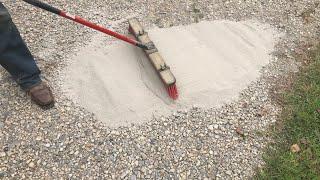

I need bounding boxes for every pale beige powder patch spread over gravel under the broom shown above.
[64,21,279,127]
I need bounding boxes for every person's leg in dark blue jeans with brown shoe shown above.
[0,3,54,108]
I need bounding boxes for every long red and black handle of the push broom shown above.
[23,0,147,48]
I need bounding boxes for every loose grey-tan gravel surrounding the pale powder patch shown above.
[0,0,320,179]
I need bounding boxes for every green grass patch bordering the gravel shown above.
[256,47,320,180]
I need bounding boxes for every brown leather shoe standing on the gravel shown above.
[28,82,54,109]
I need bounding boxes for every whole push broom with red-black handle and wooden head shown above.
[23,0,178,100]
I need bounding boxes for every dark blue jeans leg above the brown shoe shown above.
[0,3,41,90]
